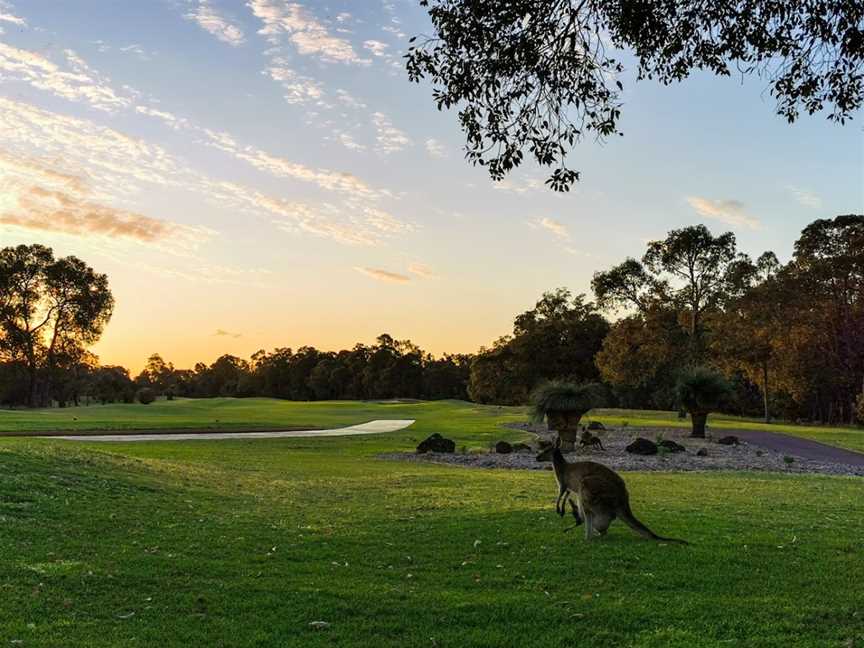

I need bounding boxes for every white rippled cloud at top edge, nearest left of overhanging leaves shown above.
[247,0,369,65]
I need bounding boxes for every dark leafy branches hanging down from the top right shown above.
[407,0,864,191]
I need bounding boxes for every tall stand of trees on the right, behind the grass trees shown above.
[469,215,864,423]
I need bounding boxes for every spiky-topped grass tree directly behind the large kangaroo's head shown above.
[531,380,604,450]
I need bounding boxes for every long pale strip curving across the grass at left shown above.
[42,419,414,443]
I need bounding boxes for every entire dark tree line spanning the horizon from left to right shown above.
[0,215,864,423]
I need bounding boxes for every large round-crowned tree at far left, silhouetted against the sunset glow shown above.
[0,245,114,407]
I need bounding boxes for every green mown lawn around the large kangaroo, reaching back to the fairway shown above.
[0,401,864,648]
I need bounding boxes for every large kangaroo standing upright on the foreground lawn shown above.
[552,446,689,544]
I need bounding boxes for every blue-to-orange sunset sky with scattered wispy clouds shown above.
[0,0,864,370]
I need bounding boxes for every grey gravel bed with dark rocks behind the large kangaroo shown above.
[381,424,864,476]
